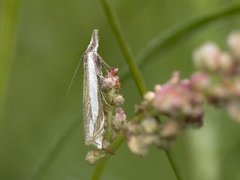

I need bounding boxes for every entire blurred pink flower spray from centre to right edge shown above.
[126,32,240,155]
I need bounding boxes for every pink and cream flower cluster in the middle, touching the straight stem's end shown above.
[127,72,204,155]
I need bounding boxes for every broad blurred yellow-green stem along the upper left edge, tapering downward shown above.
[0,0,19,115]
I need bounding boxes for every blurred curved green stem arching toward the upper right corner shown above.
[121,2,240,80]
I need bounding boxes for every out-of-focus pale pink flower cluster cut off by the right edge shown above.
[194,32,240,122]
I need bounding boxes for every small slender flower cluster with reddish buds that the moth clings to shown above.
[86,68,126,164]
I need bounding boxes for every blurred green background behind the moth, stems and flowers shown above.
[0,0,240,180]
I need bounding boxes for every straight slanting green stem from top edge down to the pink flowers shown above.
[100,0,146,95]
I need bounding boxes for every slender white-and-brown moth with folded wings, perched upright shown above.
[83,29,105,149]
